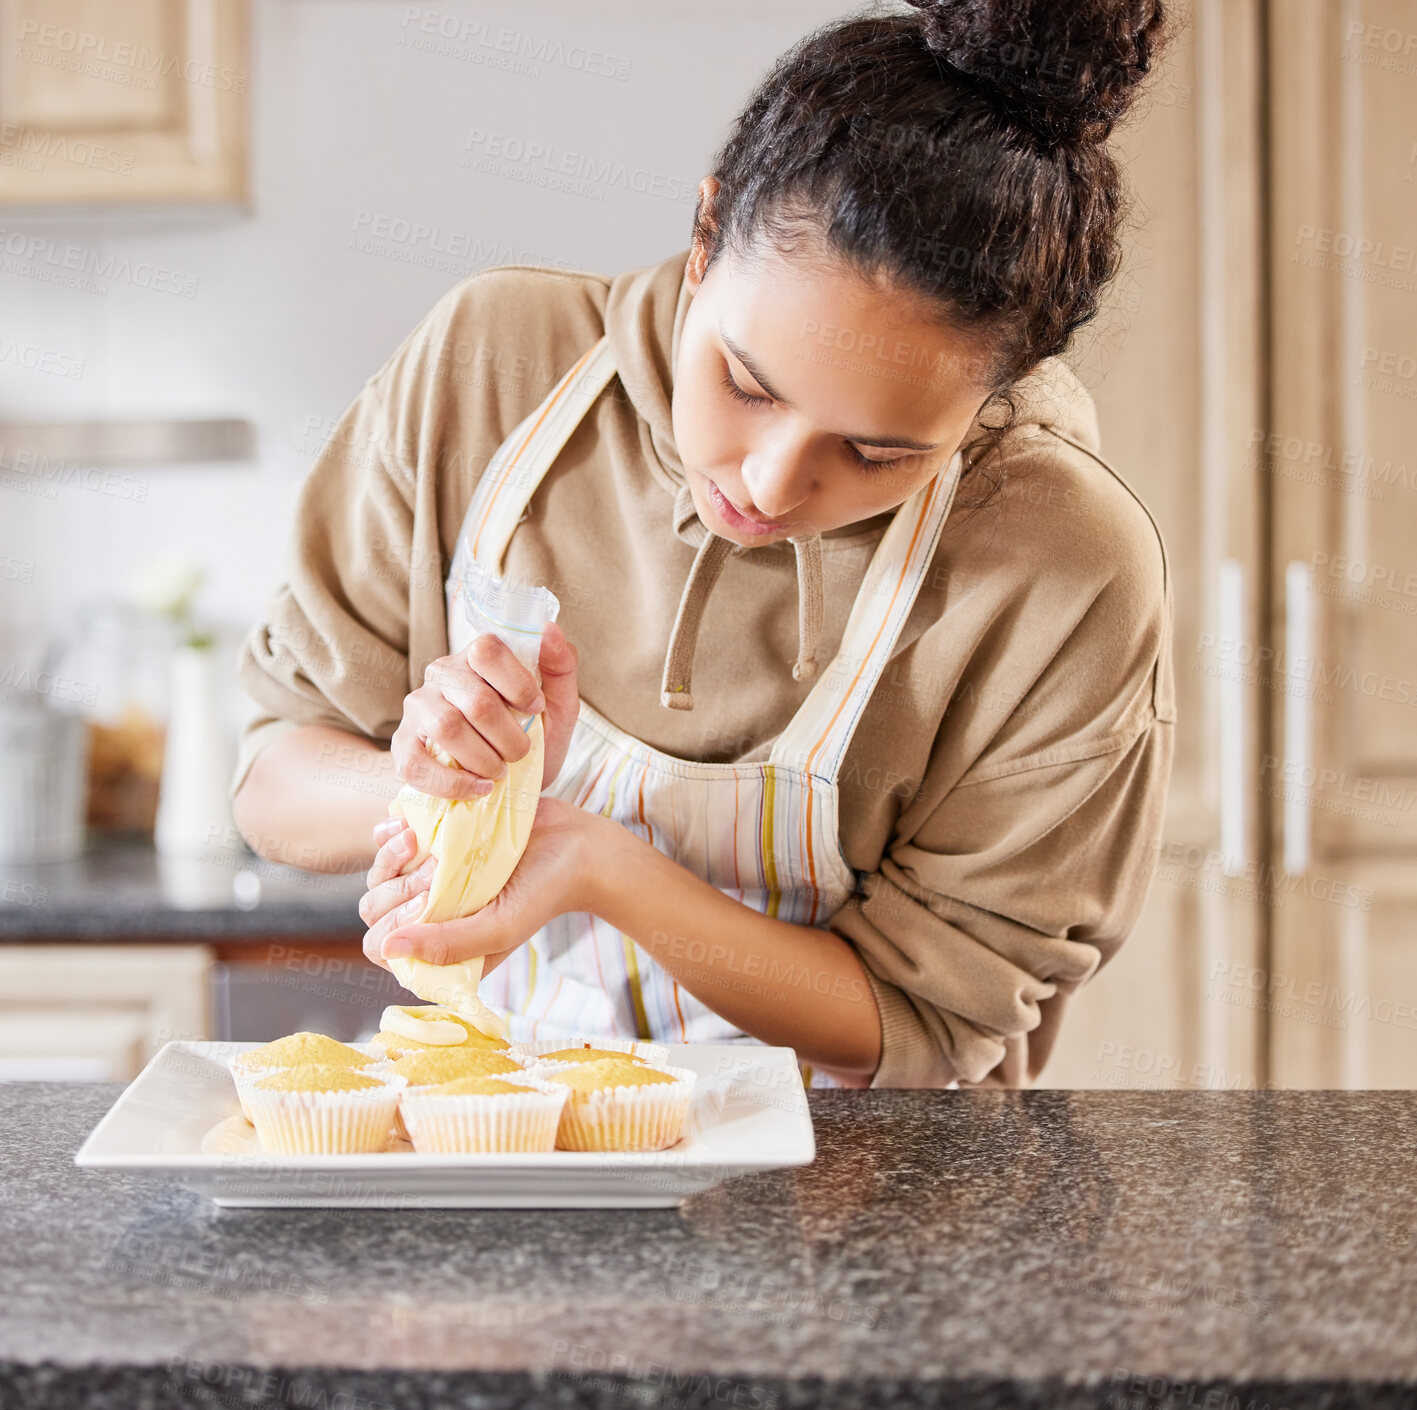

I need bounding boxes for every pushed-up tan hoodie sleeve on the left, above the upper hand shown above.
[230,269,521,796]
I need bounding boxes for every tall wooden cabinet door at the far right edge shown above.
[1260,0,1417,1087]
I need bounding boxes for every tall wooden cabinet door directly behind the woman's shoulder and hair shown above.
[1040,0,1265,1088]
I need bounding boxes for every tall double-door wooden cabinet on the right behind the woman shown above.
[1043,0,1417,1087]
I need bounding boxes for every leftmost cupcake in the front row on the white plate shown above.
[245,1064,407,1155]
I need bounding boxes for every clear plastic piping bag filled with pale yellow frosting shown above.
[385,538,561,1046]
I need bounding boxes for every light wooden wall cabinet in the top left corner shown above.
[0,0,249,205]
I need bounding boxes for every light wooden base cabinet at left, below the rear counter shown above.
[0,944,213,1081]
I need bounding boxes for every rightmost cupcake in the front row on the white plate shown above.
[533,1054,694,1151]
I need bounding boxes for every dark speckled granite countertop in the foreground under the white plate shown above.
[0,1084,1417,1410]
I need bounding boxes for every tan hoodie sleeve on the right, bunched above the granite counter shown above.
[830,478,1175,1087]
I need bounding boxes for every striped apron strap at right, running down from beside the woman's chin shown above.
[769,451,964,779]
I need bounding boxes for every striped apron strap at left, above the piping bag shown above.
[459,337,615,577]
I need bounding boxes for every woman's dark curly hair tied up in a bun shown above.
[694,0,1166,478]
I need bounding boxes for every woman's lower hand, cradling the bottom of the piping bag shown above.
[360,795,604,974]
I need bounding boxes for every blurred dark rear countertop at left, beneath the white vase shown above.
[0,835,366,942]
